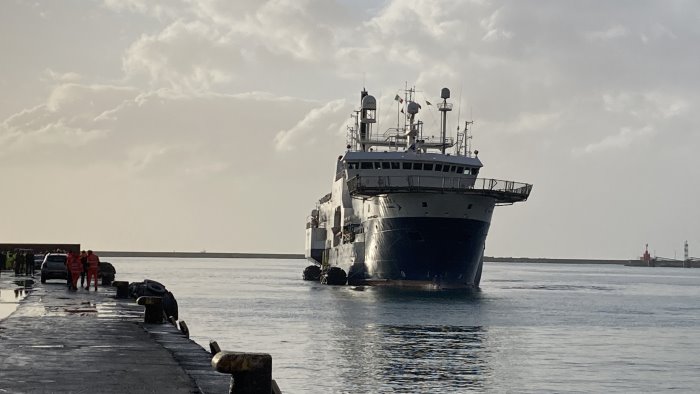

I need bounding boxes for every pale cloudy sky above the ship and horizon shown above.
[0,0,700,259]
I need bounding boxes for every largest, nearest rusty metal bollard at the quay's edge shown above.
[211,351,273,394]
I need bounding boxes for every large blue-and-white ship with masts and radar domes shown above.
[304,87,532,289]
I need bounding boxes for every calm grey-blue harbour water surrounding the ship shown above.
[109,258,700,393]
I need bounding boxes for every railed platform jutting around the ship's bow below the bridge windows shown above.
[348,175,532,204]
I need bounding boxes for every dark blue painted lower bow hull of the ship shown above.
[364,217,489,287]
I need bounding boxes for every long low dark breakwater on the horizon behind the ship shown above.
[96,250,630,265]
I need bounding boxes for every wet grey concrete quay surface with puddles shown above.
[0,271,230,393]
